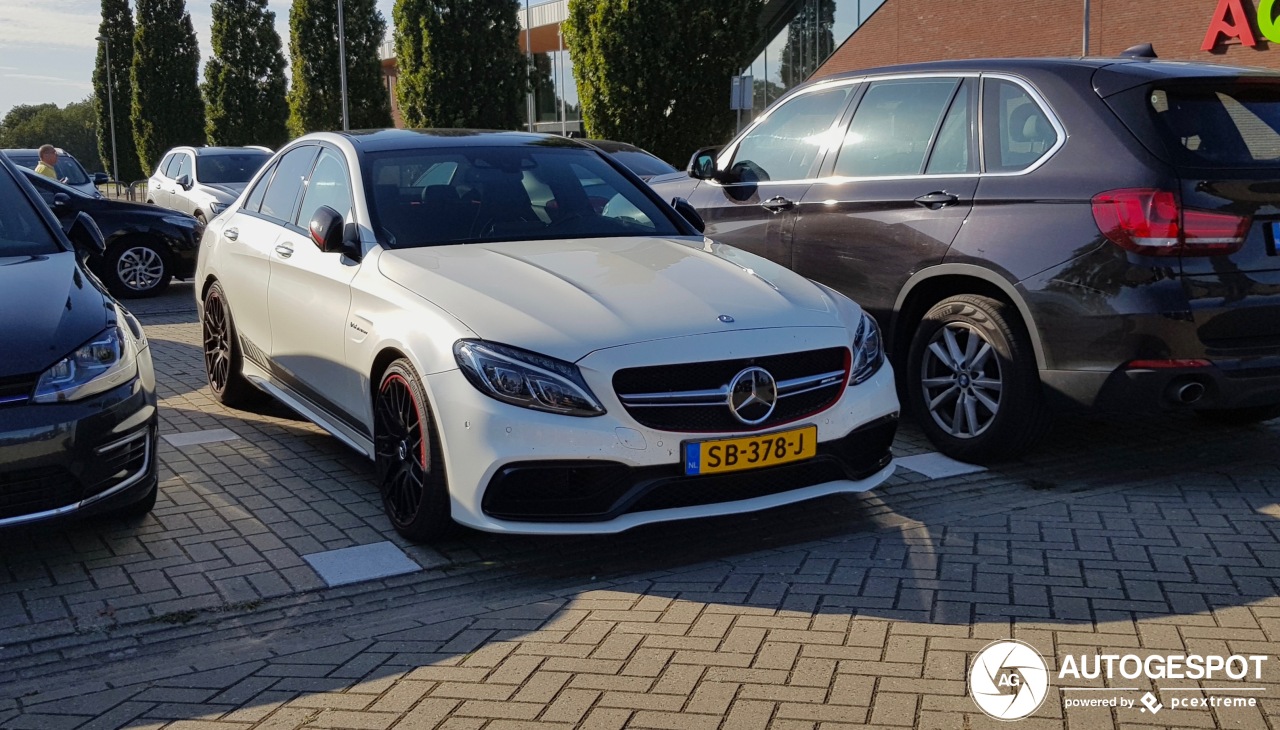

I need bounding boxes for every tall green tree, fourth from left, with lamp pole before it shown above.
[289,0,392,136]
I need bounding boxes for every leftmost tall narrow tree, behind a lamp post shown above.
[93,0,142,183]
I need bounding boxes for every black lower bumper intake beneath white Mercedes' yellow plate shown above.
[481,415,897,523]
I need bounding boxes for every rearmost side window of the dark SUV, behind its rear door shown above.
[982,78,1057,172]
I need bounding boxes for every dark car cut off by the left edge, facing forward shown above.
[0,151,157,528]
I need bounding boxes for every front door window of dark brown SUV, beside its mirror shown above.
[731,83,854,182]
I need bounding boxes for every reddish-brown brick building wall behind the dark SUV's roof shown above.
[814,0,1280,78]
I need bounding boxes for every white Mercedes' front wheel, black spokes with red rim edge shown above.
[374,359,453,542]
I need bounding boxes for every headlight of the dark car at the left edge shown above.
[32,310,141,403]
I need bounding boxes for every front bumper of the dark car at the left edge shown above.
[0,350,159,529]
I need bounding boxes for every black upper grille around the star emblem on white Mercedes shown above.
[613,347,849,433]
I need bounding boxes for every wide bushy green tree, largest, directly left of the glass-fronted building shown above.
[562,0,760,165]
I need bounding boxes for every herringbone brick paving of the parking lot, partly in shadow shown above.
[0,284,1280,730]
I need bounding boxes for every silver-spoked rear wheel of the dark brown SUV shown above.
[906,295,1050,462]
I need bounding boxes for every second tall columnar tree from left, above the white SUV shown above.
[131,0,205,175]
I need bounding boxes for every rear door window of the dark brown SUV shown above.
[835,78,960,177]
